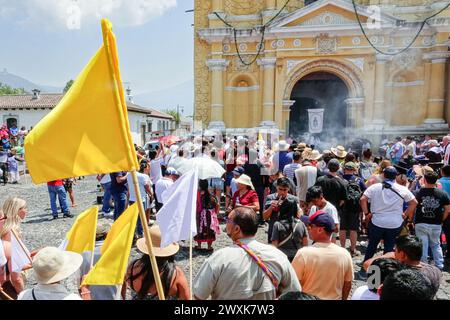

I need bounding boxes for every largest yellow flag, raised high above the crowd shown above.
[25,19,139,184]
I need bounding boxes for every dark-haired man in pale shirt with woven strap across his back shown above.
[193,207,301,300]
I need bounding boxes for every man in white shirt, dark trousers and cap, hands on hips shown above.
[360,167,417,261]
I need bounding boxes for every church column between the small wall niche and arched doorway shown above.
[258,57,277,127]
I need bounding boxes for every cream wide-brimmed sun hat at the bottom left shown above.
[32,247,83,284]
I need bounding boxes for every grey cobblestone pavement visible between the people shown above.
[0,176,450,300]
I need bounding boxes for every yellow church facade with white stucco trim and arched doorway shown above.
[195,0,450,140]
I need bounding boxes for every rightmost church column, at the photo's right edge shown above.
[424,51,449,128]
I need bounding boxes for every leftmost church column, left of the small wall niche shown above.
[206,59,230,129]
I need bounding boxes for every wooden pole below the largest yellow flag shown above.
[131,170,165,300]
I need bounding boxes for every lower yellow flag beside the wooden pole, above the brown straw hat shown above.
[82,203,138,286]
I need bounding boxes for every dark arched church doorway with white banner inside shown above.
[289,72,351,144]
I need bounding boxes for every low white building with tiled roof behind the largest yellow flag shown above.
[0,90,174,146]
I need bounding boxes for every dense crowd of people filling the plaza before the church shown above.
[0,131,450,300]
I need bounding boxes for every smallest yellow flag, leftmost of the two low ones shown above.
[66,206,98,253]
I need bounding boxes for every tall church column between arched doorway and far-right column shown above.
[372,54,392,127]
